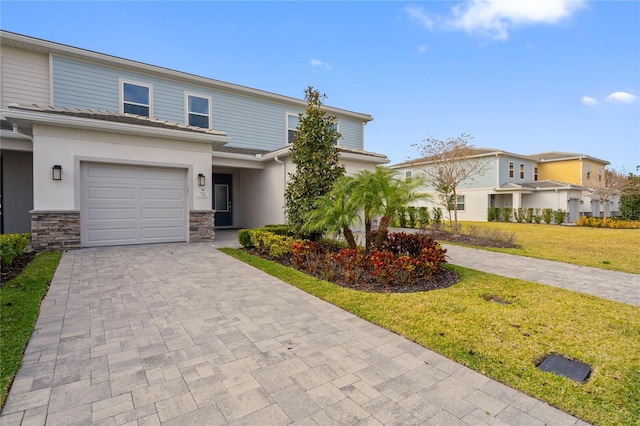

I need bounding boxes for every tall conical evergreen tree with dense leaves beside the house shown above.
[285,86,345,239]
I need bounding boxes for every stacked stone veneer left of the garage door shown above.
[29,210,80,251]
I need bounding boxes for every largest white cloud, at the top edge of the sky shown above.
[405,0,586,40]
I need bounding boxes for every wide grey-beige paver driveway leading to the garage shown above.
[0,244,584,425]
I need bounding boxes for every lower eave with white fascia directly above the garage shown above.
[0,109,229,144]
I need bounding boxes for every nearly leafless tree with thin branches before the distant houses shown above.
[417,133,490,232]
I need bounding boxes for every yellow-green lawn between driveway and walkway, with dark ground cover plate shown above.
[222,249,640,425]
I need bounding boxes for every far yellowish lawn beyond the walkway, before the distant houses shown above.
[450,222,640,274]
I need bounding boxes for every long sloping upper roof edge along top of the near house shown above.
[0,30,373,122]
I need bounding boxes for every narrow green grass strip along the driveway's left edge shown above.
[0,252,62,407]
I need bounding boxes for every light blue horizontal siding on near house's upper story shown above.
[53,56,364,151]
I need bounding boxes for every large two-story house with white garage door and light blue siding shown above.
[0,31,388,250]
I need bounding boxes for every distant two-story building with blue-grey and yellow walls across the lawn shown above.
[390,148,609,222]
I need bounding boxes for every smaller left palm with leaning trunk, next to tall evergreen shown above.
[302,176,361,249]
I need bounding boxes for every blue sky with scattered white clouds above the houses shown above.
[0,0,640,171]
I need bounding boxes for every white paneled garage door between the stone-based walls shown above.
[80,163,187,247]
